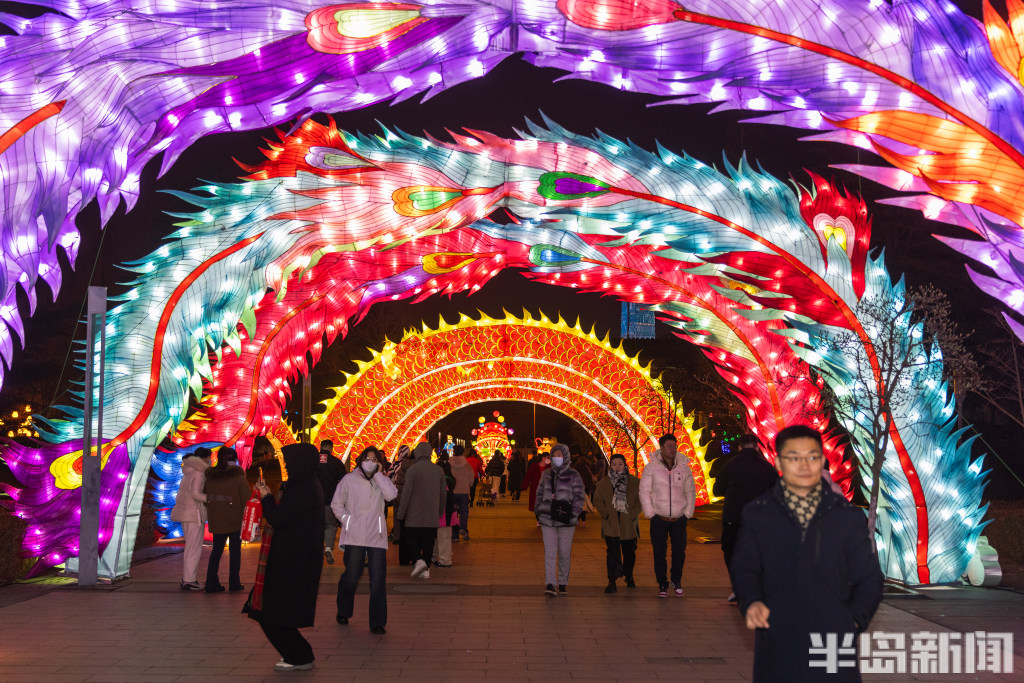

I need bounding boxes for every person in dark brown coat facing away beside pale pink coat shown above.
[205,445,249,593]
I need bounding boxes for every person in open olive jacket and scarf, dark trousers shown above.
[594,453,641,593]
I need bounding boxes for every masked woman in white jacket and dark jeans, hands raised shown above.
[331,446,398,634]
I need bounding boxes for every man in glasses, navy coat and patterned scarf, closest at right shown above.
[730,425,884,683]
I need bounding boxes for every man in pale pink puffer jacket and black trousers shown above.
[640,434,697,598]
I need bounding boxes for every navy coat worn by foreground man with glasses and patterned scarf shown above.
[730,483,884,683]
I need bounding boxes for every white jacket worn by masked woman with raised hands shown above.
[331,468,398,550]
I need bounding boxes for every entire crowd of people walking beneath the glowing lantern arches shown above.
[171,426,883,680]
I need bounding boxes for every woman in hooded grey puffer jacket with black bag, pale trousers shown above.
[534,443,586,595]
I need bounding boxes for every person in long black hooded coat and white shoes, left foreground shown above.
[244,443,324,671]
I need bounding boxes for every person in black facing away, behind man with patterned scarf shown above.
[713,434,778,602]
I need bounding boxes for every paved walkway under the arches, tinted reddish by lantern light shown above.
[0,501,1024,683]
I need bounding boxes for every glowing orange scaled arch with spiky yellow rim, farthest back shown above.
[313,313,711,503]
